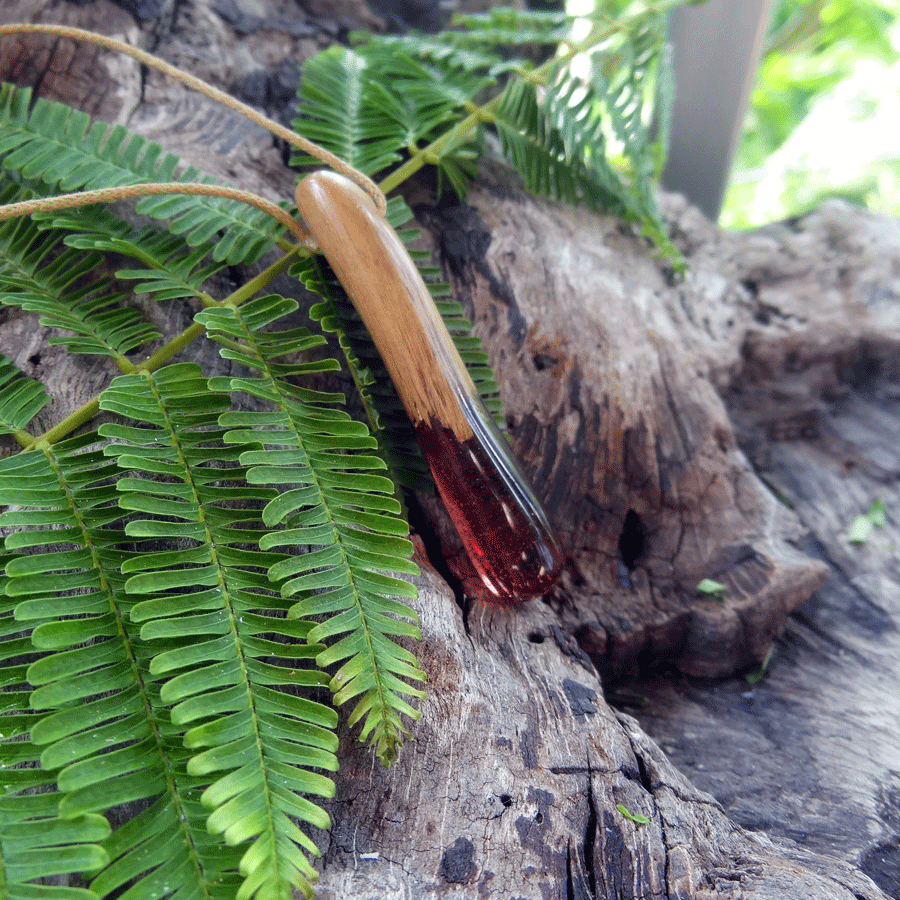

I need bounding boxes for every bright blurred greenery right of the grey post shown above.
[722,0,900,227]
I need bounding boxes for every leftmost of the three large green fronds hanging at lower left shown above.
[0,434,238,900]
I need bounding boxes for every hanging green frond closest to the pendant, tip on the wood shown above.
[196,296,424,760]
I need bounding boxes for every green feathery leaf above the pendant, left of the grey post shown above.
[294,10,676,258]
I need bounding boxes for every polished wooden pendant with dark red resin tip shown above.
[296,171,562,604]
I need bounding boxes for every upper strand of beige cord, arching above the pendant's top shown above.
[0,23,387,217]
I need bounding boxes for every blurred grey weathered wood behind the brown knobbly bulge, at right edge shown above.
[627,195,900,897]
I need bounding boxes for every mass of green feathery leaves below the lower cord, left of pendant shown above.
[0,81,432,898]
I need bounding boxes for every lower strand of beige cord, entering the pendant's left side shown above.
[0,181,318,252]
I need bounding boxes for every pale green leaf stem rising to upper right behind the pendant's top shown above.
[378,0,695,194]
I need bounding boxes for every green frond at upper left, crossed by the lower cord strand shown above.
[0,84,283,265]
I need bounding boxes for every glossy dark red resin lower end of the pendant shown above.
[416,403,562,603]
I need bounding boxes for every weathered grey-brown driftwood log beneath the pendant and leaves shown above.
[0,0,900,900]
